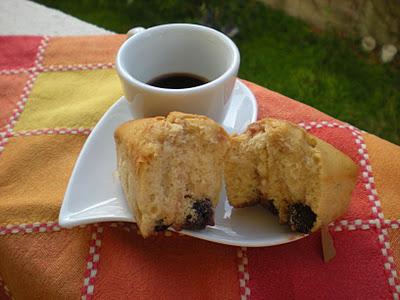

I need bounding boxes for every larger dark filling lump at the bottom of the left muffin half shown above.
[183,198,214,230]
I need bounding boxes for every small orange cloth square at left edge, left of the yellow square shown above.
[0,74,29,131]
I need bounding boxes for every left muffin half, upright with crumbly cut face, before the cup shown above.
[114,112,229,237]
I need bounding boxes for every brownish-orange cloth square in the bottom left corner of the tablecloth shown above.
[0,228,90,299]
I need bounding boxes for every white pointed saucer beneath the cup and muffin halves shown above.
[59,81,304,247]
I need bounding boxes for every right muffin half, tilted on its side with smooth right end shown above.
[225,118,358,233]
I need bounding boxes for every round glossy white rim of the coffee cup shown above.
[116,23,240,94]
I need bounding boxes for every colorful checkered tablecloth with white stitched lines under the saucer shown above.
[0,35,400,299]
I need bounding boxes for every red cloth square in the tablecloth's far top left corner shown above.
[0,36,42,69]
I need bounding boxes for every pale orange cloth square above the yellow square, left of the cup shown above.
[43,34,126,66]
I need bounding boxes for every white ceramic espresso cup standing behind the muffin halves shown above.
[116,24,240,122]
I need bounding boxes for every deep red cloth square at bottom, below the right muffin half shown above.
[247,230,392,299]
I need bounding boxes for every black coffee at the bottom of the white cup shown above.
[147,73,209,89]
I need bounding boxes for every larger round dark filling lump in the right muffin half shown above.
[288,203,317,233]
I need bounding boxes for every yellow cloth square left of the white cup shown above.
[15,69,122,131]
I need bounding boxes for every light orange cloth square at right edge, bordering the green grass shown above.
[363,133,400,219]
